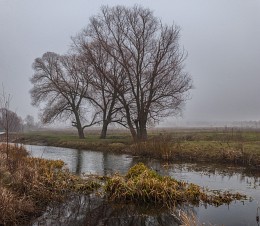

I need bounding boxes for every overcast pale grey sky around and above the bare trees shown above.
[0,0,260,125]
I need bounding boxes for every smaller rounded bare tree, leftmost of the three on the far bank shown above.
[30,52,99,139]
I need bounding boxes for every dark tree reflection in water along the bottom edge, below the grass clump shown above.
[32,195,179,226]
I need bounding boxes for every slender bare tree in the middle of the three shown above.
[74,40,122,139]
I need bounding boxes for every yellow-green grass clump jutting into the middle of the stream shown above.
[105,163,244,207]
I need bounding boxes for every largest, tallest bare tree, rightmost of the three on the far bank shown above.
[78,6,192,140]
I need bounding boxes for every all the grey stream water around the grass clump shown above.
[26,145,260,226]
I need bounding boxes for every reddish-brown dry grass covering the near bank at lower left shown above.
[0,145,100,225]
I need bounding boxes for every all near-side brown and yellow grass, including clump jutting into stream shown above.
[0,143,252,225]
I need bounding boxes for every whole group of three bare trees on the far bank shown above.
[30,6,192,140]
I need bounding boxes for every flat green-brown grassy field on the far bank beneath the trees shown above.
[19,128,260,168]
